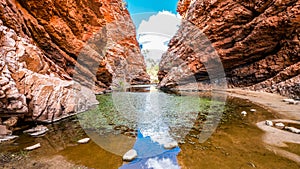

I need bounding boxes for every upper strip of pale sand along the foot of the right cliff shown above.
[223,89,300,120]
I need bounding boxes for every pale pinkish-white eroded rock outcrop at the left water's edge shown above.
[0,23,98,121]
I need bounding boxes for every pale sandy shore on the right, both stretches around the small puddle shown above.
[222,89,300,165]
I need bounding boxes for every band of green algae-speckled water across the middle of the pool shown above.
[77,92,224,137]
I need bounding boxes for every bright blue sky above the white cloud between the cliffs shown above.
[125,0,178,27]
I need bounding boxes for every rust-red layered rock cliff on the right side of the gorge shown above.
[158,0,300,98]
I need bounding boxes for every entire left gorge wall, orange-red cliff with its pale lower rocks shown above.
[0,0,149,121]
